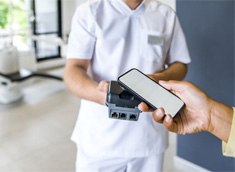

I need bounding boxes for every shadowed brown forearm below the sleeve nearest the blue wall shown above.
[152,62,187,81]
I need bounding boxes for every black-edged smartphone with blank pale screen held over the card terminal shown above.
[118,68,184,117]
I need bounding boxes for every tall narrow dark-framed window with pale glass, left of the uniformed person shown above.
[31,0,62,61]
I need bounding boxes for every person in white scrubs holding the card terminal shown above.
[64,0,190,172]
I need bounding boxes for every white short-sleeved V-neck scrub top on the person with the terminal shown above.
[67,0,190,157]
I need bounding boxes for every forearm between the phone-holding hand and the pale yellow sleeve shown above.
[208,100,233,142]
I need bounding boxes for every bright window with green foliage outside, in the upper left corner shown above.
[0,0,28,49]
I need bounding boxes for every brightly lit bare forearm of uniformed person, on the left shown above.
[64,62,105,104]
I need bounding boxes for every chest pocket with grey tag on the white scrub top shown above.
[144,31,165,63]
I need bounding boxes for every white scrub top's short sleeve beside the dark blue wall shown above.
[167,15,191,64]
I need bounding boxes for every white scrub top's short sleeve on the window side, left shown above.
[67,4,96,60]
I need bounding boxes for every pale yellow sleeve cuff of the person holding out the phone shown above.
[222,108,235,157]
